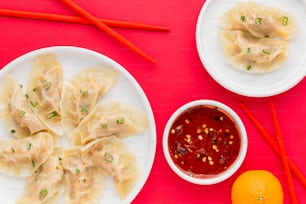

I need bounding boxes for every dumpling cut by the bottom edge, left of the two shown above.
[16,149,64,204]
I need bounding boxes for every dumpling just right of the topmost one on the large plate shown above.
[61,67,118,137]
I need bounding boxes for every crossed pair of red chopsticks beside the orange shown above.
[240,103,306,204]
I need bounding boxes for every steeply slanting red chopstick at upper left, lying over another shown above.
[60,0,156,63]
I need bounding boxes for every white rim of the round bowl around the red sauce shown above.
[162,99,248,185]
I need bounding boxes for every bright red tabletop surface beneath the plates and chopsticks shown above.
[0,0,306,204]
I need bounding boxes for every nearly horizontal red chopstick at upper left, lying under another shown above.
[0,8,170,31]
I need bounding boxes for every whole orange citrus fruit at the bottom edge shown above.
[231,170,284,204]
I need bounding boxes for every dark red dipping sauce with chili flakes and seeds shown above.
[168,105,241,176]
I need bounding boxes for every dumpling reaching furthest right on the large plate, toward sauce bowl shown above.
[72,102,148,145]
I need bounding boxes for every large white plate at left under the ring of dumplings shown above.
[0,47,156,204]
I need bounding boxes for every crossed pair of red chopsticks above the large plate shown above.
[0,0,169,63]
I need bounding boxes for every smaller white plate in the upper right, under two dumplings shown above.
[196,0,306,97]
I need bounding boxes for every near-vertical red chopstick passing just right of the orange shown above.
[270,103,298,204]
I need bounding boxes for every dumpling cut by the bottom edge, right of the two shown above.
[63,147,104,204]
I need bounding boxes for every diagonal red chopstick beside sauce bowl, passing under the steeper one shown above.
[240,103,306,188]
